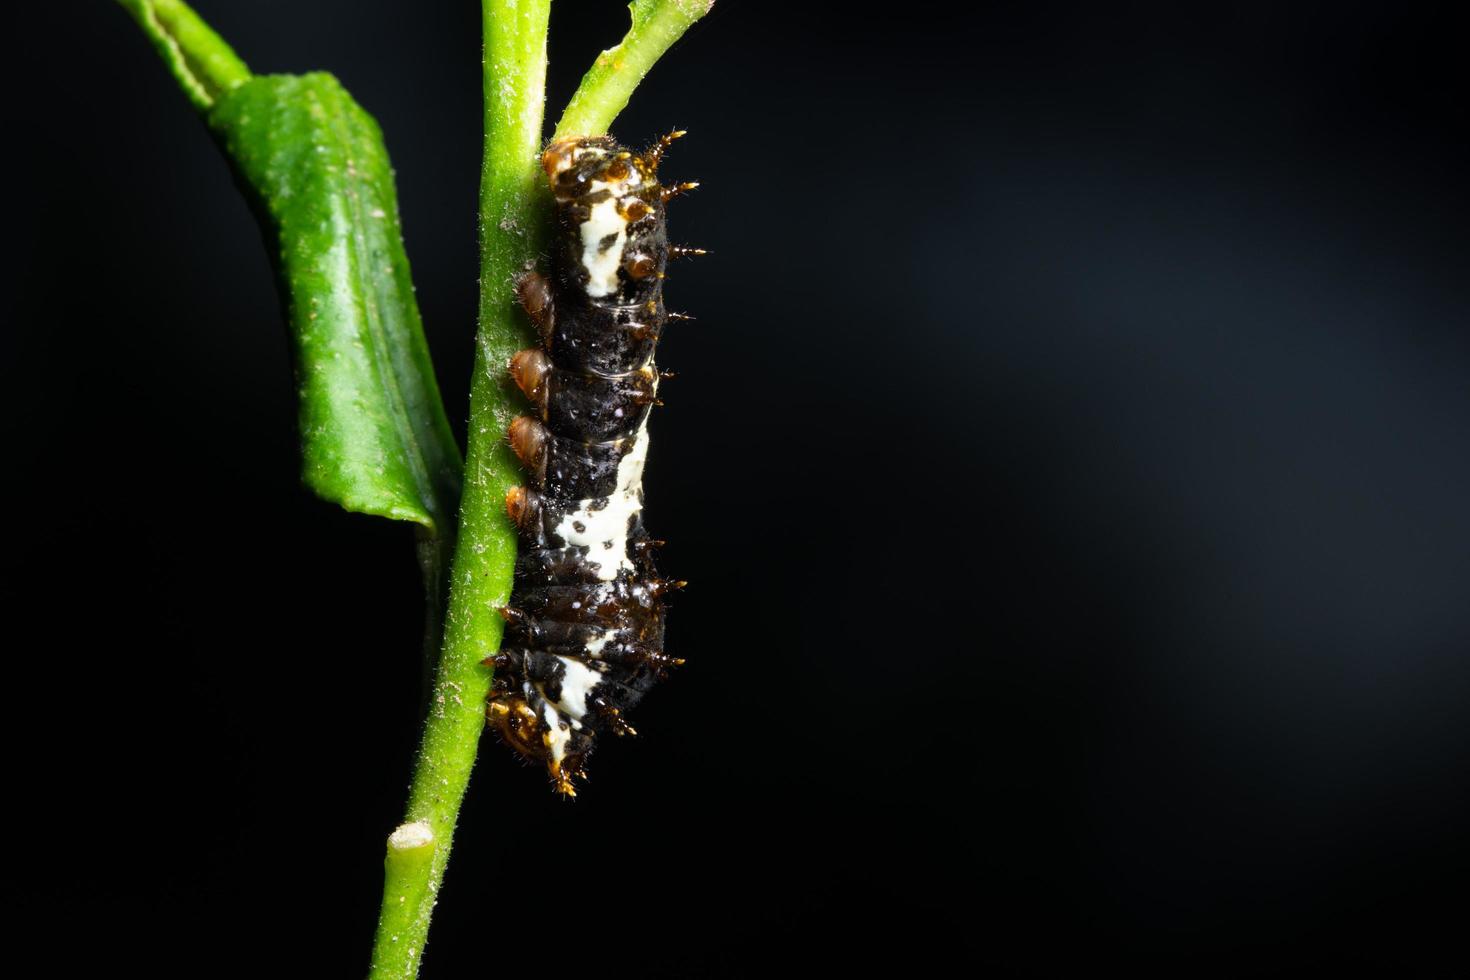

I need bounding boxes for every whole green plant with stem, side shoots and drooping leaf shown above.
[119,0,713,977]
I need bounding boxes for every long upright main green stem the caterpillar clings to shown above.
[372,0,551,980]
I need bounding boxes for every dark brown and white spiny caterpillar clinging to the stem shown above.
[487,131,703,796]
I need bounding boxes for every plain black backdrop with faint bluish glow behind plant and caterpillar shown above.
[11,0,1470,979]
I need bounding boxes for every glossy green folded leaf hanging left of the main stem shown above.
[206,73,462,532]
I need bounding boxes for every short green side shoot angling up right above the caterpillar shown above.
[556,0,714,138]
